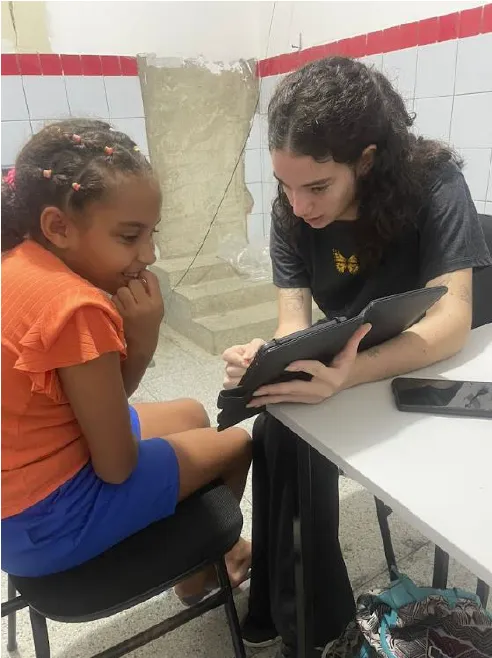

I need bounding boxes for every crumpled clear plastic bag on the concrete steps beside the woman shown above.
[217,235,272,281]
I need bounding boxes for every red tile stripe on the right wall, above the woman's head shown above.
[256,3,492,78]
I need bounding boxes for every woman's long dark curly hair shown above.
[268,57,461,267]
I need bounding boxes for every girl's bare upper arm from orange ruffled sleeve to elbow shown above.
[58,352,138,484]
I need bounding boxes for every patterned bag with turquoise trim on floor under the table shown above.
[323,575,492,658]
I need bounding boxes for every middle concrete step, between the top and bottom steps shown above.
[168,276,277,319]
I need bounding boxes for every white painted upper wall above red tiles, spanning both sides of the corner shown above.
[26,0,483,62]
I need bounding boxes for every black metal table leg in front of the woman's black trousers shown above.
[294,438,314,658]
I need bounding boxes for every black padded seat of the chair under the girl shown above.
[11,484,243,622]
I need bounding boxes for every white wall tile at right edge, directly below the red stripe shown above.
[455,33,492,94]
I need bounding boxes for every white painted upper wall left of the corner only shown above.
[46,0,262,61]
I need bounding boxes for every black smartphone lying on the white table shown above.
[391,377,492,418]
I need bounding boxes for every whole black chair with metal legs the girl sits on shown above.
[2,484,245,658]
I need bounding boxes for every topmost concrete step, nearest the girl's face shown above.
[151,255,236,292]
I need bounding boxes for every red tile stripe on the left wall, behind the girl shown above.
[2,54,138,76]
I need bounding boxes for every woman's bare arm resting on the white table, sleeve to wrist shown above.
[344,269,472,388]
